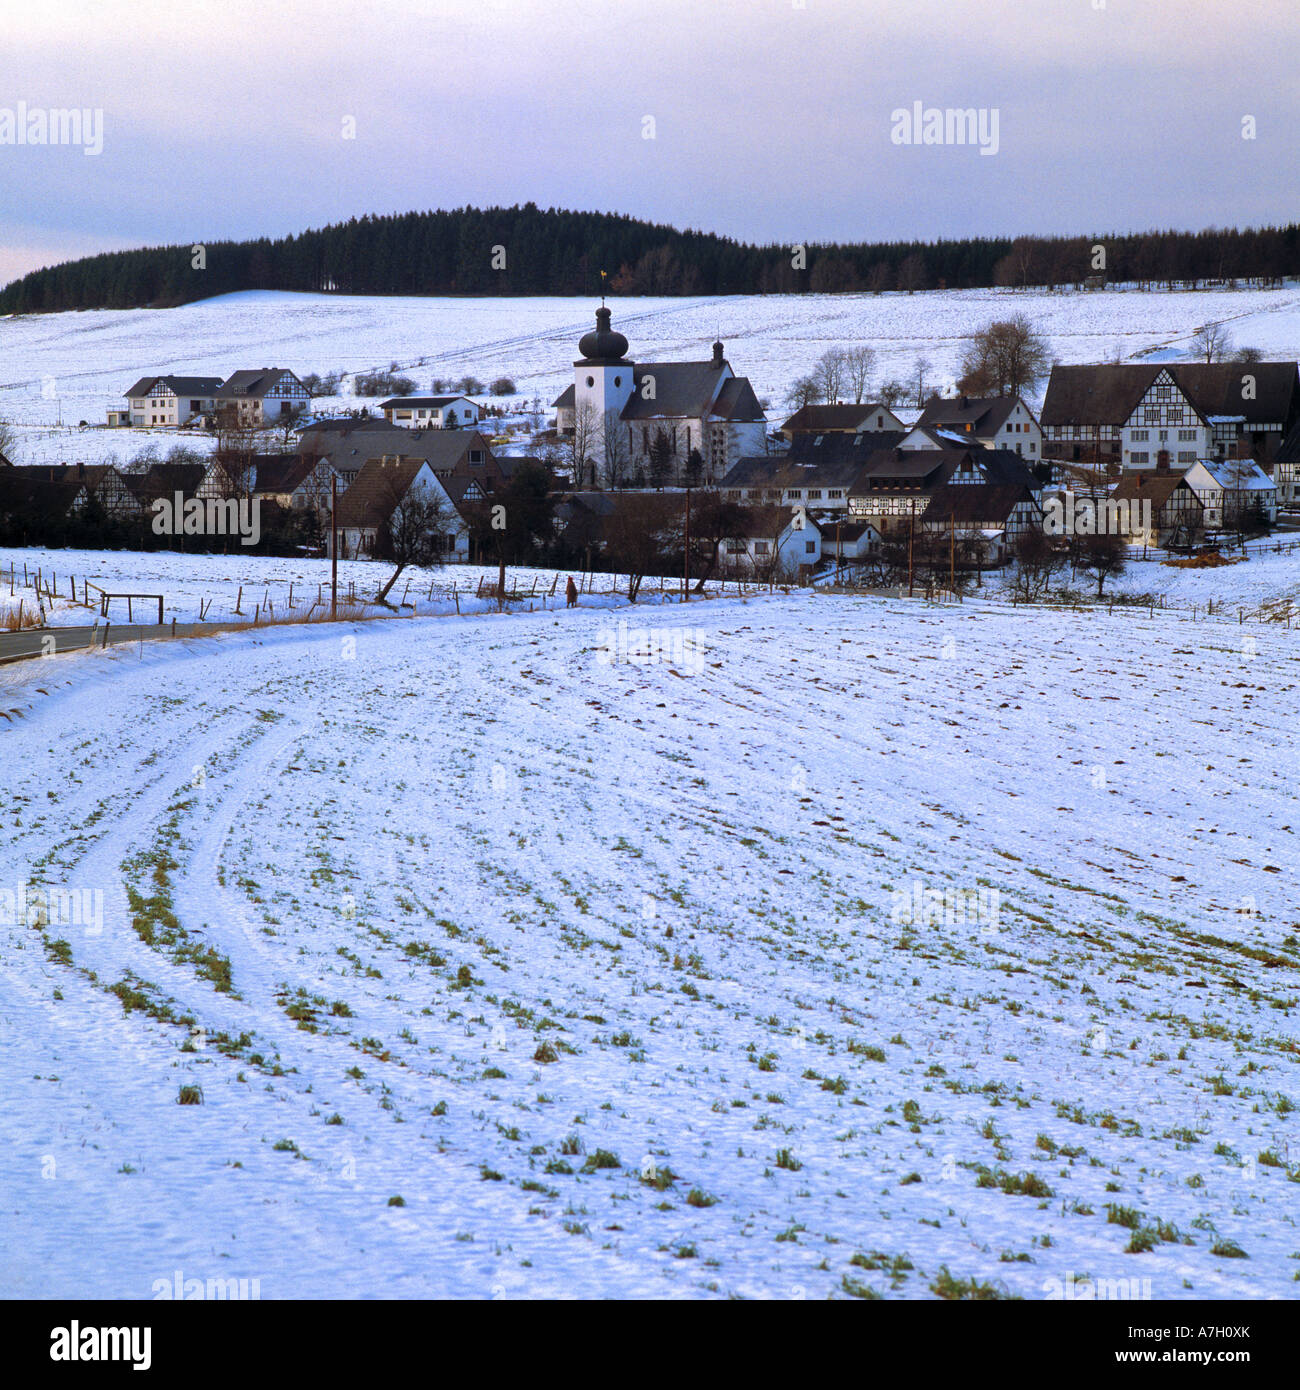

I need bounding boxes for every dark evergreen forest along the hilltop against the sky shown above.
[0,203,1300,314]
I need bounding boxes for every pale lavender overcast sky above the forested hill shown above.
[0,0,1300,282]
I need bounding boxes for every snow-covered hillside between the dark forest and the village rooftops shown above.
[0,285,1300,463]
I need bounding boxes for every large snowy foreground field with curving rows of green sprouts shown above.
[0,589,1300,1300]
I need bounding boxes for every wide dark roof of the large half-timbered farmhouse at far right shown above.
[1039,361,1300,425]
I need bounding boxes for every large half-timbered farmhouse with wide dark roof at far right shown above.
[1040,361,1300,468]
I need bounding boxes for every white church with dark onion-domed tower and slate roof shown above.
[553,300,767,488]
